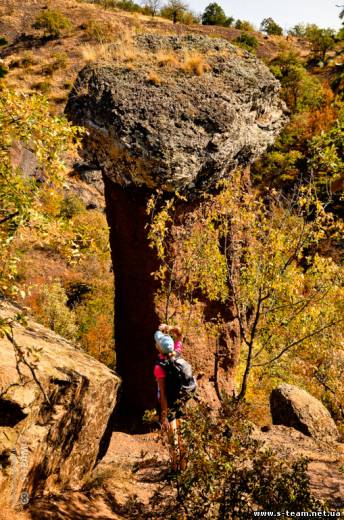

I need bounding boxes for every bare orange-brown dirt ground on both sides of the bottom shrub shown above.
[19,426,344,520]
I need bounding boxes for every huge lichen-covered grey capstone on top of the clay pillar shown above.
[66,35,286,193]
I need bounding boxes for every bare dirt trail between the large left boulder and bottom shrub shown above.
[22,432,168,520]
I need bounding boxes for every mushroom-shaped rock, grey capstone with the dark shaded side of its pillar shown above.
[66,35,287,416]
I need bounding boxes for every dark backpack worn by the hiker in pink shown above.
[158,356,197,408]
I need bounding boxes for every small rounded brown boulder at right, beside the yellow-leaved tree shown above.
[270,383,339,440]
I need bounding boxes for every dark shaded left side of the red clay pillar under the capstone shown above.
[105,178,159,417]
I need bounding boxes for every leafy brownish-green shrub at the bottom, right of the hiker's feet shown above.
[146,403,320,520]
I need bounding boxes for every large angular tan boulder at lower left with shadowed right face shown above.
[0,303,119,504]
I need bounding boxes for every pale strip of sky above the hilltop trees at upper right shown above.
[188,0,344,29]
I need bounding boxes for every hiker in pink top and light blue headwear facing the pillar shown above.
[154,323,196,470]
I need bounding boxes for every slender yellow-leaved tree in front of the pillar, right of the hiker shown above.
[149,173,344,399]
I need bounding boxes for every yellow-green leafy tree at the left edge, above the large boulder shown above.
[0,88,79,297]
